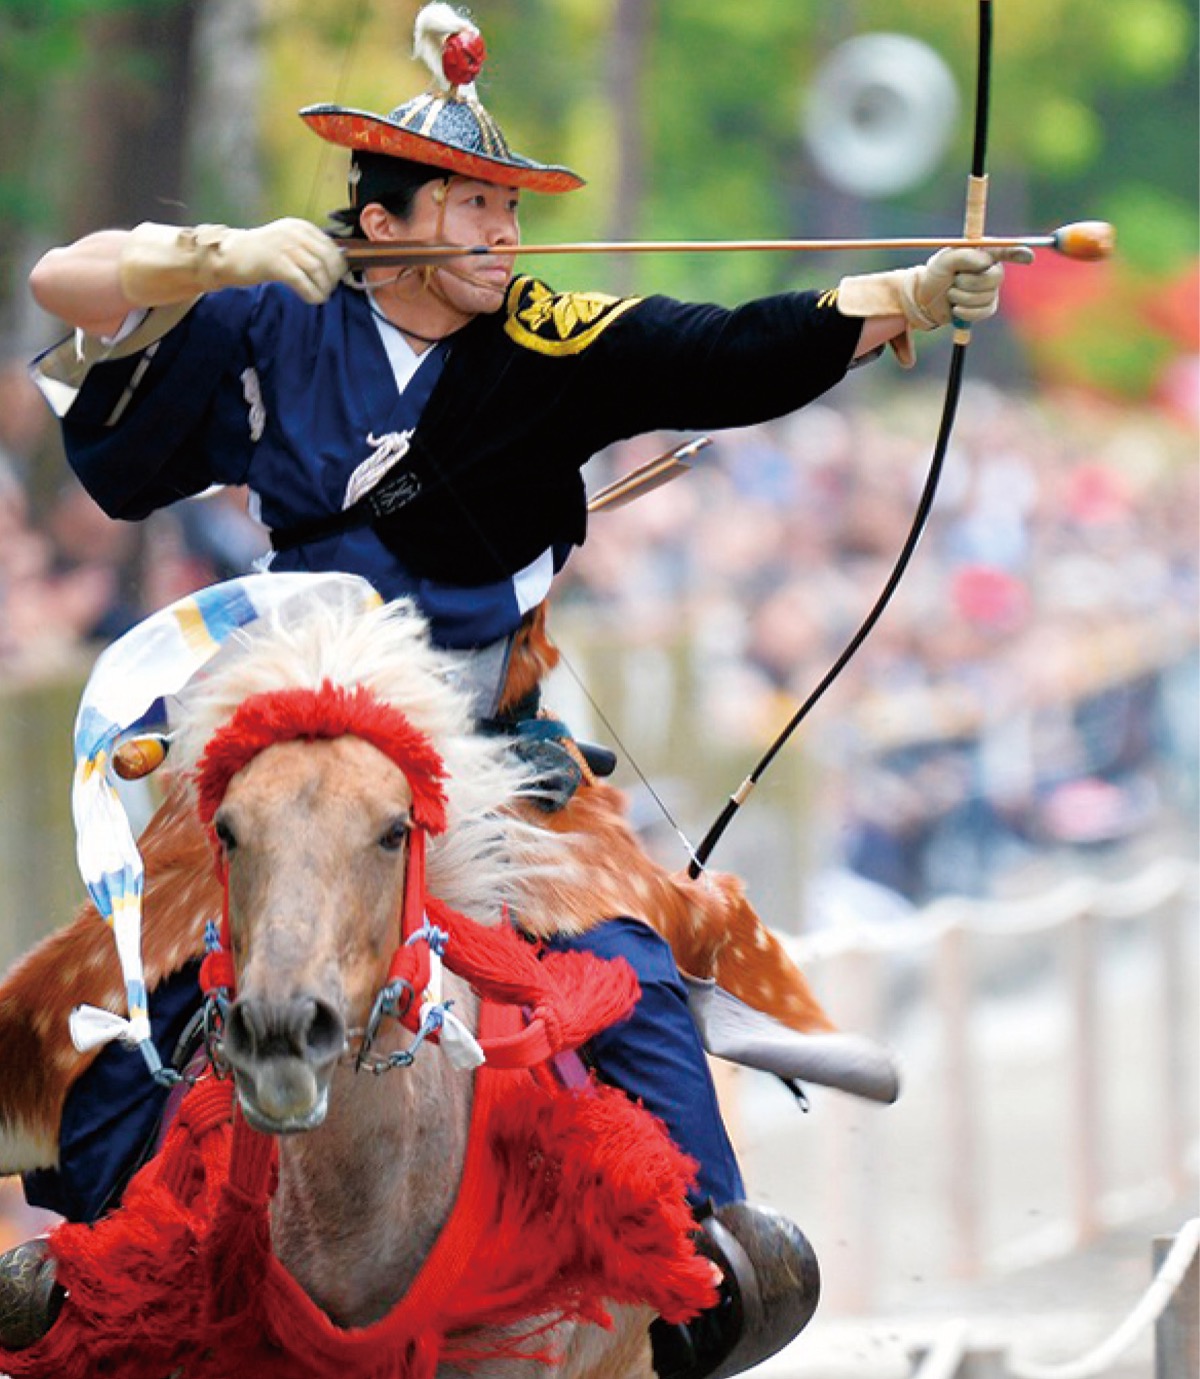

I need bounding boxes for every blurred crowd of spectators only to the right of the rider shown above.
[571,387,1197,902]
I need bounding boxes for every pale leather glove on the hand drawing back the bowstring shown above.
[117,217,346,306]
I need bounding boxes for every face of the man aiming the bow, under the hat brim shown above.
[396,177,521,316]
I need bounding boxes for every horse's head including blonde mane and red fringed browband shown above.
[168,605,545,1134]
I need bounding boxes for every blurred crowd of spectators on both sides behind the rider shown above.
[0,350,1200,902]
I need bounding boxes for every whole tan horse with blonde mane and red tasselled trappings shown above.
[3,587,716,1379]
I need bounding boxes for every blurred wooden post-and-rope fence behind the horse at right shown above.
[731,858,1200,1314]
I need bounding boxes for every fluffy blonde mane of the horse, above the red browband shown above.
[171,600,567,921]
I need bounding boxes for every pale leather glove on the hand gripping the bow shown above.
[837,245,1033,367]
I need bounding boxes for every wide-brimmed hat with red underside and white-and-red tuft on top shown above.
[301,3,583,192]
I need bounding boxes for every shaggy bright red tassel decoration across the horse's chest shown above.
[0,1007,716,1379]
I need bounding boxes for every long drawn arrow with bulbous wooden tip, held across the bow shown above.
[341,221,1116,269]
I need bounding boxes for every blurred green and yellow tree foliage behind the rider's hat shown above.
[7,0,1200,390]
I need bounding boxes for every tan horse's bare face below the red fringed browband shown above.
[212,735,412,1134]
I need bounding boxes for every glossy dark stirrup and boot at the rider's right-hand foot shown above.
[650,1202,821,1379]
